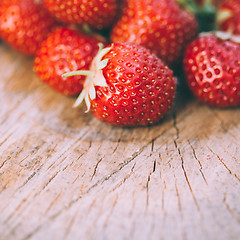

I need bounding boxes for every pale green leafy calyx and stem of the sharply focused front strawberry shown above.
[62,43,112,112]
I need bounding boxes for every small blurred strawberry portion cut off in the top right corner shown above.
[217,0,240,34]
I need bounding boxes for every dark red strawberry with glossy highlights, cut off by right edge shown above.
[184,32,240,107]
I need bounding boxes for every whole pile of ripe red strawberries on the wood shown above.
[0,0,240,126]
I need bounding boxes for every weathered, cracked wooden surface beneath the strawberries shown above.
[0,45,240,240]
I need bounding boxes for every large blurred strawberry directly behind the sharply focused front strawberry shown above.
[111,0,197,65]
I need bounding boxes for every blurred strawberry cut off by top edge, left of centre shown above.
[44,0,117,29]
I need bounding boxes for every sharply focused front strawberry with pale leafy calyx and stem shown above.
[65,43,176,126]
